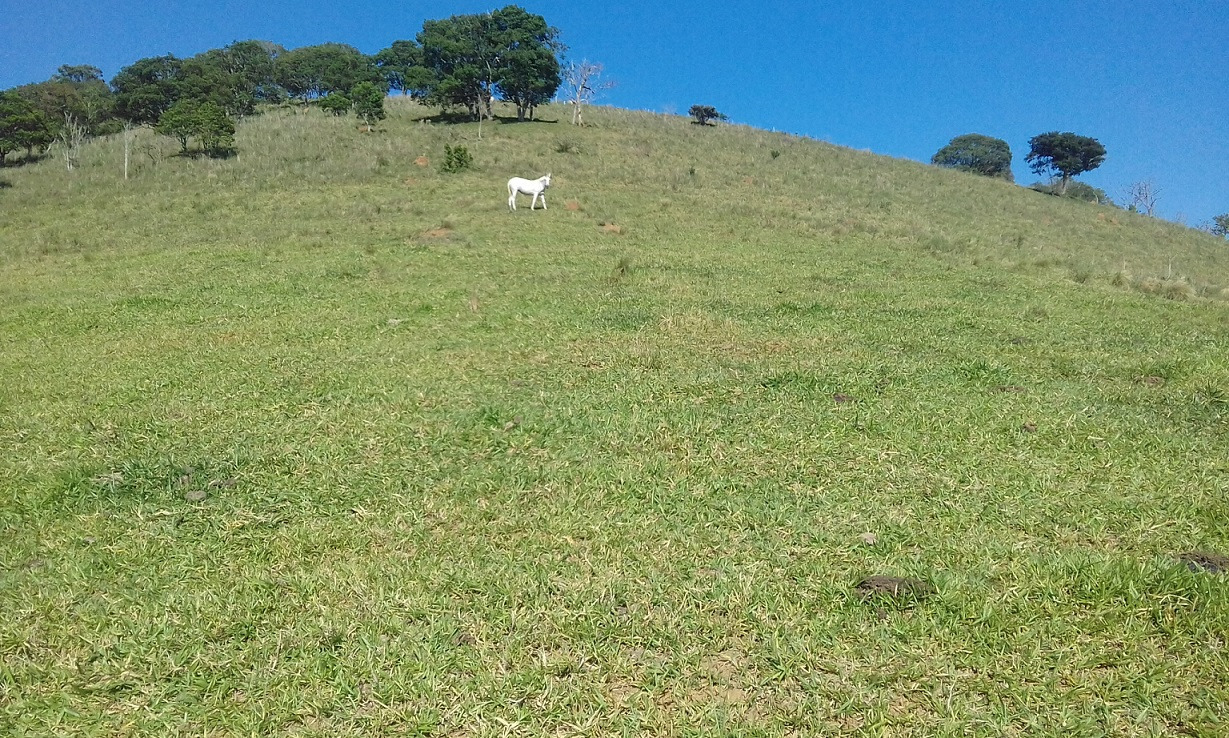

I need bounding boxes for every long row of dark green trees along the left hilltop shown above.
[0,5,564,166]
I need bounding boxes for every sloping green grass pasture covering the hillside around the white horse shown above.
[0,101,1229,738]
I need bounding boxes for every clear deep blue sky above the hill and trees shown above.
[0,0,1229,225]
